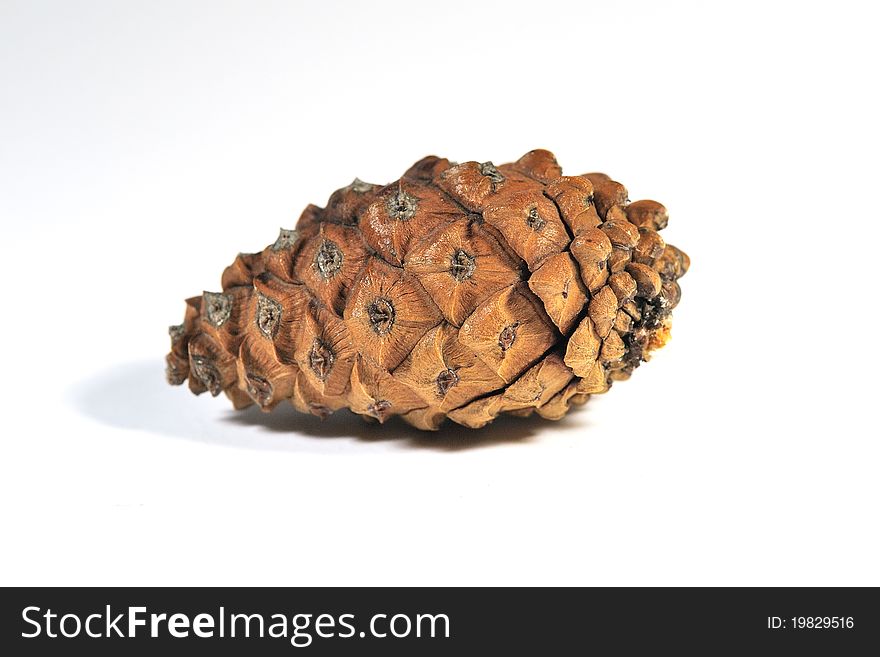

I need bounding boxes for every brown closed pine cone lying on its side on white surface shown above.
[167,150,689,429]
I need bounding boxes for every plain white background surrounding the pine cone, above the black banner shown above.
[0,0,880,585]
